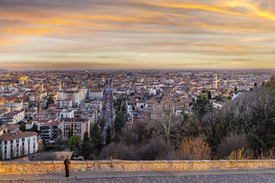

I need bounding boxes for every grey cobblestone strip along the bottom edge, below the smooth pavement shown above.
[1,174,275,183]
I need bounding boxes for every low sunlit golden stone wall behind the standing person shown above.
[0,160,275,174]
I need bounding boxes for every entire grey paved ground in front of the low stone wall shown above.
[0,169,275,182]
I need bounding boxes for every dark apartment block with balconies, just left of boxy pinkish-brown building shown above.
[40,121,59,140]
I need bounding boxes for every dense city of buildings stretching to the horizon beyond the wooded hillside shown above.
[0,69,274,160]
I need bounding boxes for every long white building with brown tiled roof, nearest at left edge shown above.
[0,132,38,160]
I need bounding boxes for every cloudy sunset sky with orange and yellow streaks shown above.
[0,0,275,70]
